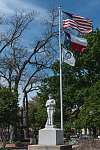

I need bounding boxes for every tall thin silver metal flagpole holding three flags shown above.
[59,5,63,130]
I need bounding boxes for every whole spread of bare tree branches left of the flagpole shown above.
[0,8,58,141]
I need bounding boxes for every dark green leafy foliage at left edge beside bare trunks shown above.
[0,87,18,127]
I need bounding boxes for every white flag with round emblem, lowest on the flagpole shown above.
[62,48,75,66]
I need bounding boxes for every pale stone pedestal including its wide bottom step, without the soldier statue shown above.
[28,126,72,150]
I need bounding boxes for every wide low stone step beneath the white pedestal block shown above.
[28,145,72,150]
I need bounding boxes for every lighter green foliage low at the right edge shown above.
[77,81,100,130]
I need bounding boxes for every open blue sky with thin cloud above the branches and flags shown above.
[0,0,100,105]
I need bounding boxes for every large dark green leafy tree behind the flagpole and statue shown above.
[30,28,100,134]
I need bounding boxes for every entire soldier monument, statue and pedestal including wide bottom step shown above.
[28,94,72,150]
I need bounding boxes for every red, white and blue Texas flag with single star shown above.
[64,32,87,52]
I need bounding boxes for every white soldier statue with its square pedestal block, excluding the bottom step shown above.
[39,94,63,145]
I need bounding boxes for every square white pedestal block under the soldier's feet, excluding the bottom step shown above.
[38,126,64,145]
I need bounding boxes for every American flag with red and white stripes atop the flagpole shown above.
[62,12,92,34]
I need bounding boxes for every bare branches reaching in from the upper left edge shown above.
[0,10,37,53]
